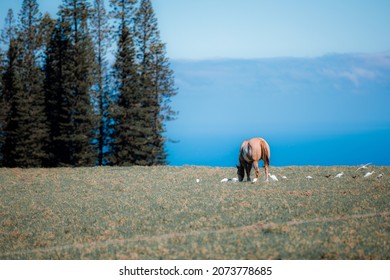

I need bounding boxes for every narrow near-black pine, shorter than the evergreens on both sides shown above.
[44,19,74,167]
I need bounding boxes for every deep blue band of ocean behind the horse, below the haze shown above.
[167,129,390,167]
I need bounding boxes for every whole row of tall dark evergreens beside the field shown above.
[0,0,177,167]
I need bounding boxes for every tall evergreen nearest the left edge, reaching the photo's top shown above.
[4,0,48,167]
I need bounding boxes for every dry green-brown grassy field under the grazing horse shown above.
[0,166,390,259]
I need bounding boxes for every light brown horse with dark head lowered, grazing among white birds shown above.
[237,138,271,182]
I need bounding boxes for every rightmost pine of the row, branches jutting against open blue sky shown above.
[135,0,176,165]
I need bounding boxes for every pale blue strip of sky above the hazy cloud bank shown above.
[0,0,390,59]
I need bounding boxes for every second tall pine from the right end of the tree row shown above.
[110,0,148,165]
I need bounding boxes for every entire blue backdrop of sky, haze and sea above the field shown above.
[0,0,390,166]
